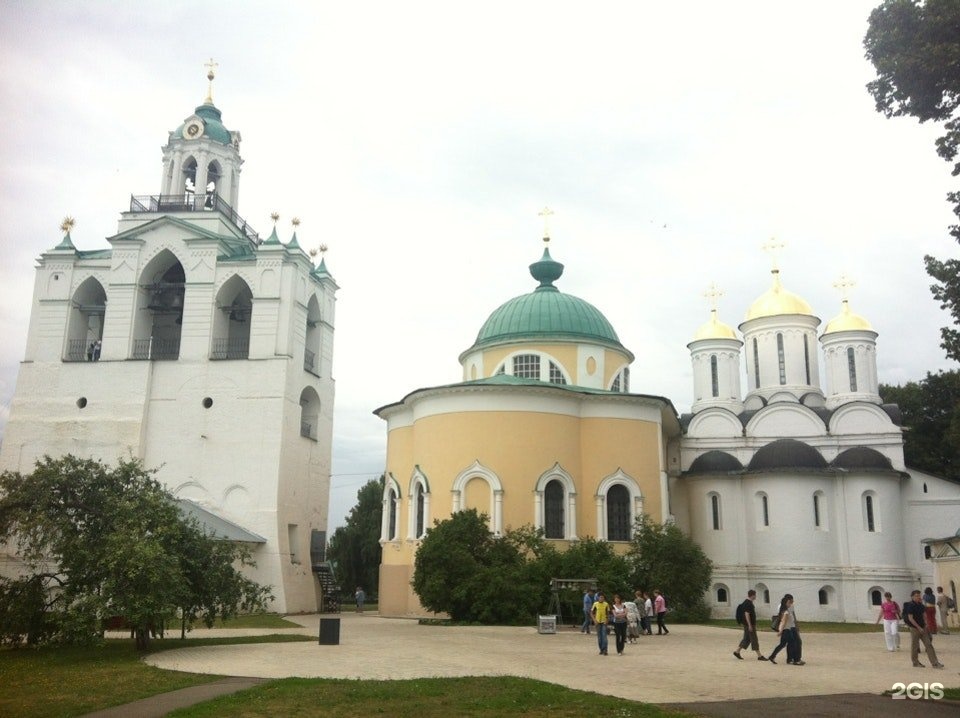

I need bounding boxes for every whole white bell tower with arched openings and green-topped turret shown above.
[0,70,337,612]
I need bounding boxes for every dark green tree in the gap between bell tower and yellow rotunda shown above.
[327,476,384,595]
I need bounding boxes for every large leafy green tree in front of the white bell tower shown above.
[0,456,269,649]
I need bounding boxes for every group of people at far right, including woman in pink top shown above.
[876,586,952,668]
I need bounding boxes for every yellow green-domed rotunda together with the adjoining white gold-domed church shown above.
[375,233,960,621]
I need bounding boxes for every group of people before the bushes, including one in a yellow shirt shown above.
[580,588,670,656]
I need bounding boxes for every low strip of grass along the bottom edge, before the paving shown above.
[169,677,689,718]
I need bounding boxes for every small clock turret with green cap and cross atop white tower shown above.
[160,59,243,210]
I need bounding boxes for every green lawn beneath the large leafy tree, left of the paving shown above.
[0,635,316,718]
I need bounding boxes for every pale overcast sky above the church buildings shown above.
[0,0,958,530]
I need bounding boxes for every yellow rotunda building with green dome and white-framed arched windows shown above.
[375,238,680,616]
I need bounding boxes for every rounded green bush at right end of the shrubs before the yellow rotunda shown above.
[627,515,713,621]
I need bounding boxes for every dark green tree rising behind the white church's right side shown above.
[880,371,960,479]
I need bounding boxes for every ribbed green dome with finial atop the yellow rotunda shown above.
[468,249,624,351]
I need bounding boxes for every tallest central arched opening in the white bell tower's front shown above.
[130,249,186,359]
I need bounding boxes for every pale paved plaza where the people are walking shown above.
[137,613,960,716]
